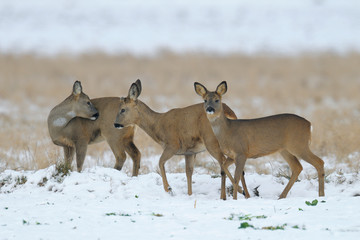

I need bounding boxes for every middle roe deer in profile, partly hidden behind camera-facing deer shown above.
[114,80,248,199]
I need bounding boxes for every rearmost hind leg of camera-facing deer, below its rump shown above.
[301,148,325,197]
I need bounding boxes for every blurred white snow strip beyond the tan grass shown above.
[0,0,360,55]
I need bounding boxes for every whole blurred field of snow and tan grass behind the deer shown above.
[0,0,360,178]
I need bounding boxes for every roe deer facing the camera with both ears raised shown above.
[194,81,325,199]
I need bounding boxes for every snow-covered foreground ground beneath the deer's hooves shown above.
[0,166,360,239]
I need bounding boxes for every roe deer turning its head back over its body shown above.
[48,81,141,176]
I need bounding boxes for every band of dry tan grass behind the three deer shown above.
[0,52,360,172]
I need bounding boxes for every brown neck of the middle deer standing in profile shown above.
[138,100,162,143]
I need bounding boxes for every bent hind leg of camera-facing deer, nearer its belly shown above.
[279,150,303,199]
